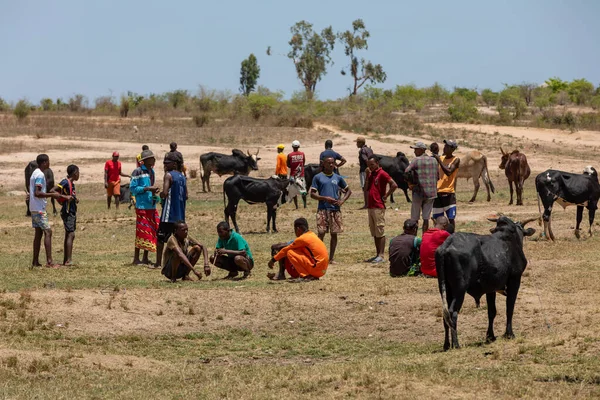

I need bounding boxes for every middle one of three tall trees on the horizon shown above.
[284,21,335,100]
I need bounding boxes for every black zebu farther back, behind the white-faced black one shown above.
[200,149,260,192]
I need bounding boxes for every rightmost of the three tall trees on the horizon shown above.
[337,19,387,96]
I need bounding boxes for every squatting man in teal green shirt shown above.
[210,221,254,279]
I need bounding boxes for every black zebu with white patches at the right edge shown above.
[535,166,600,240]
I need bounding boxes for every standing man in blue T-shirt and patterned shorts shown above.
[310,157,352,264]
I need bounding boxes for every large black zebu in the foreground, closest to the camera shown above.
[435,216,537,350]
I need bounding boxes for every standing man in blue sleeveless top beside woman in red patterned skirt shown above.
[154,152,188,268]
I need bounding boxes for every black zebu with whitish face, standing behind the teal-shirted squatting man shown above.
[223,175,306,232]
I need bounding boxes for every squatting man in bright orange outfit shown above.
[267,218,329,281]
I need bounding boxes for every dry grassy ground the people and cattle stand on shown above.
[0,113,600,399]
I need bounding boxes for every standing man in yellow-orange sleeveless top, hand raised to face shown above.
[433,140,460,226]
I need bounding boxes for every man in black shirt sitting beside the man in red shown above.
[390,219,421,278]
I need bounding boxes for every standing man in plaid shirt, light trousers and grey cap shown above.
[405,142,438,233]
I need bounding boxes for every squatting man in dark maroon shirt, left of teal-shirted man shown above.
[161,221,210,282]
